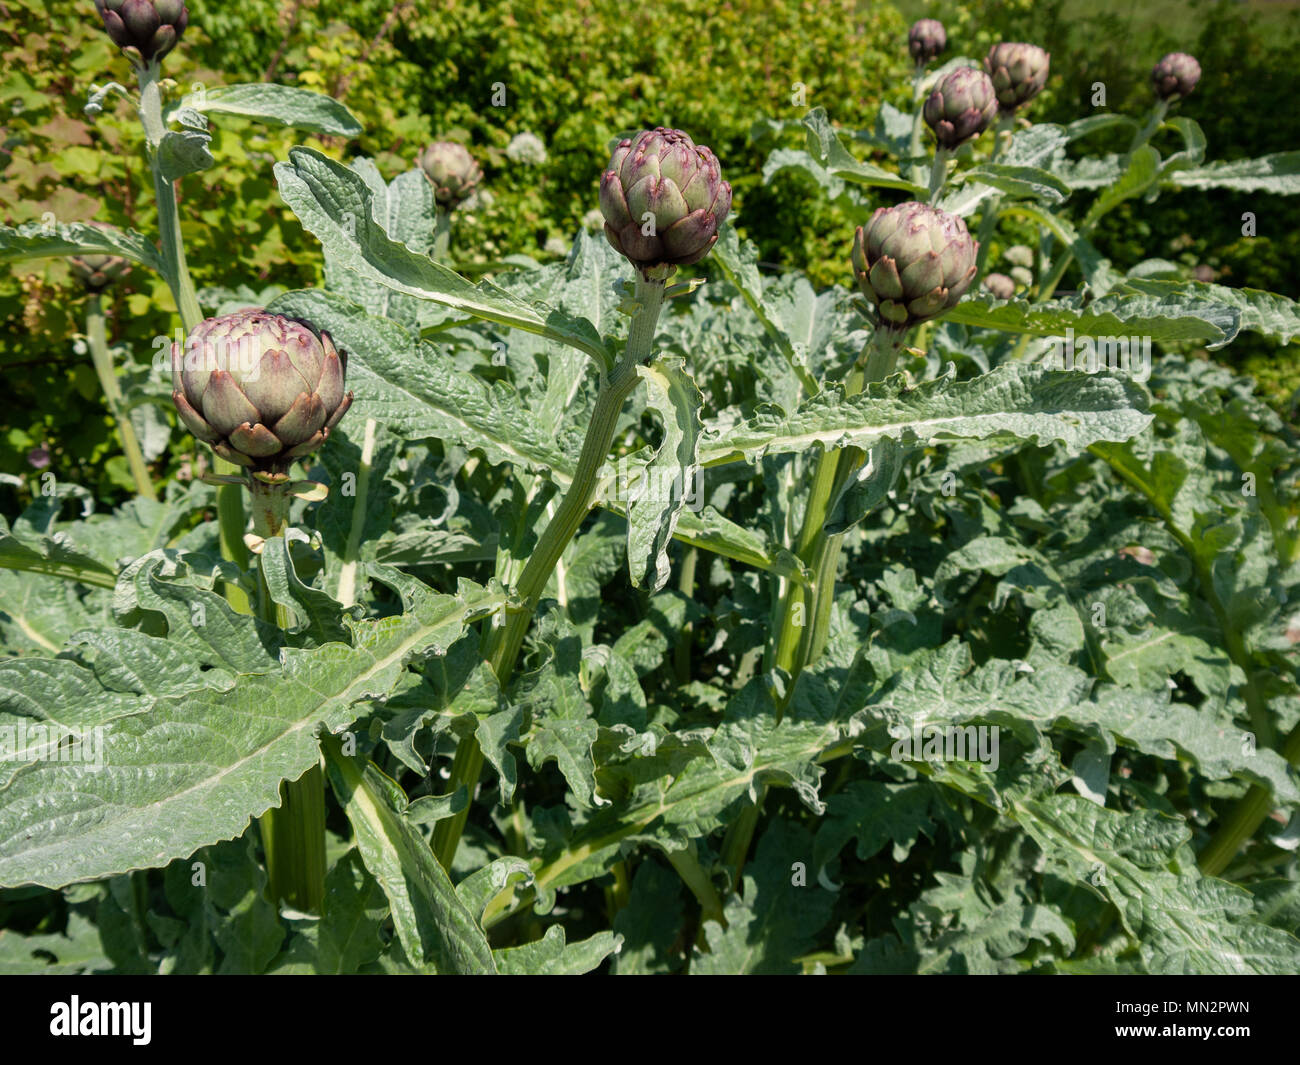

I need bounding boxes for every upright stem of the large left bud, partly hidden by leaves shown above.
[251,480,325,913]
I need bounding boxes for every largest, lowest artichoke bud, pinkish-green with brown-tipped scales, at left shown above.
[172,308,352,484]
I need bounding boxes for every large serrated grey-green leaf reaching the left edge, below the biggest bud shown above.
[0,573,504,887]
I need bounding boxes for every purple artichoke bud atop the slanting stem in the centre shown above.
[601,126,731,270]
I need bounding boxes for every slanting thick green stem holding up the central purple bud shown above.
[433,272,664,869]
